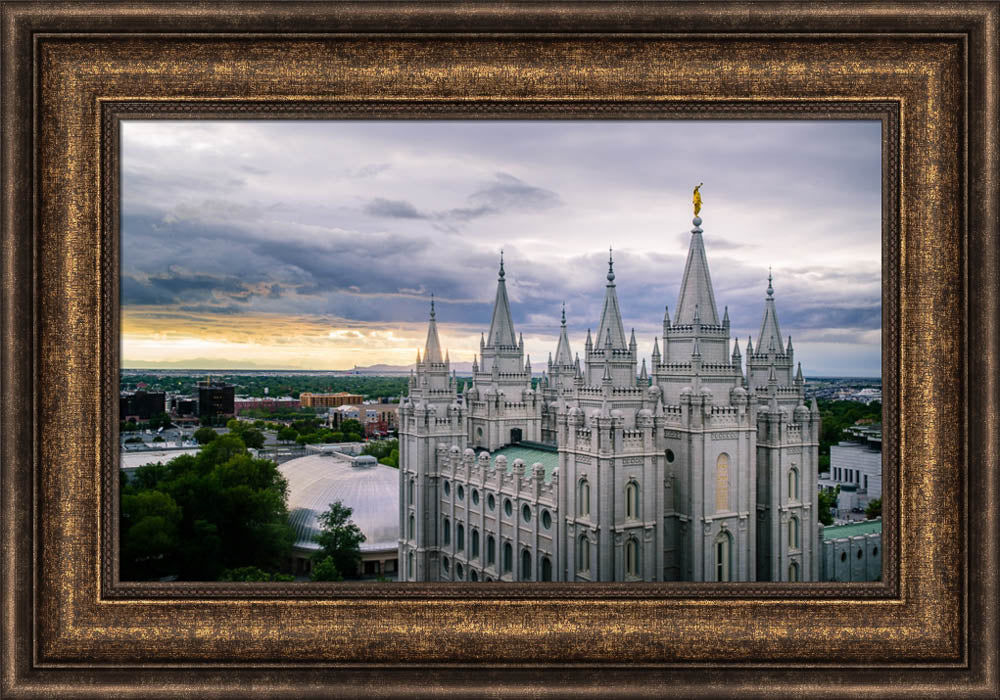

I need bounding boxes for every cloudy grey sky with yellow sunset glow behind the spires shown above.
[122,121,881,376]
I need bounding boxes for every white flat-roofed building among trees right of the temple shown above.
[819,425,882,518]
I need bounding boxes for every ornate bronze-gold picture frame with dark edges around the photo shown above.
[0,2,1000,697]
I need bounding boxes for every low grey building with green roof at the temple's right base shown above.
[820,518,882,581]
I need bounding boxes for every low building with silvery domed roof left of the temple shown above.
[278,452,399,576]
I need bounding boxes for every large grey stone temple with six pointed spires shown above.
[398,211,820,581]
